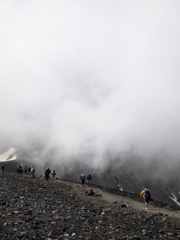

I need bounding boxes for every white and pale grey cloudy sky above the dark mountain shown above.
[0,0,180,165]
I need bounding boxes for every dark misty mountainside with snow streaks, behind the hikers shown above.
[1,149,180,209]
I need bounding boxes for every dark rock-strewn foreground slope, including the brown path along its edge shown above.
[0,172,180,240]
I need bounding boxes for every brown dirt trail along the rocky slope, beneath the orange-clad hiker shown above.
[58,180,180,218]
